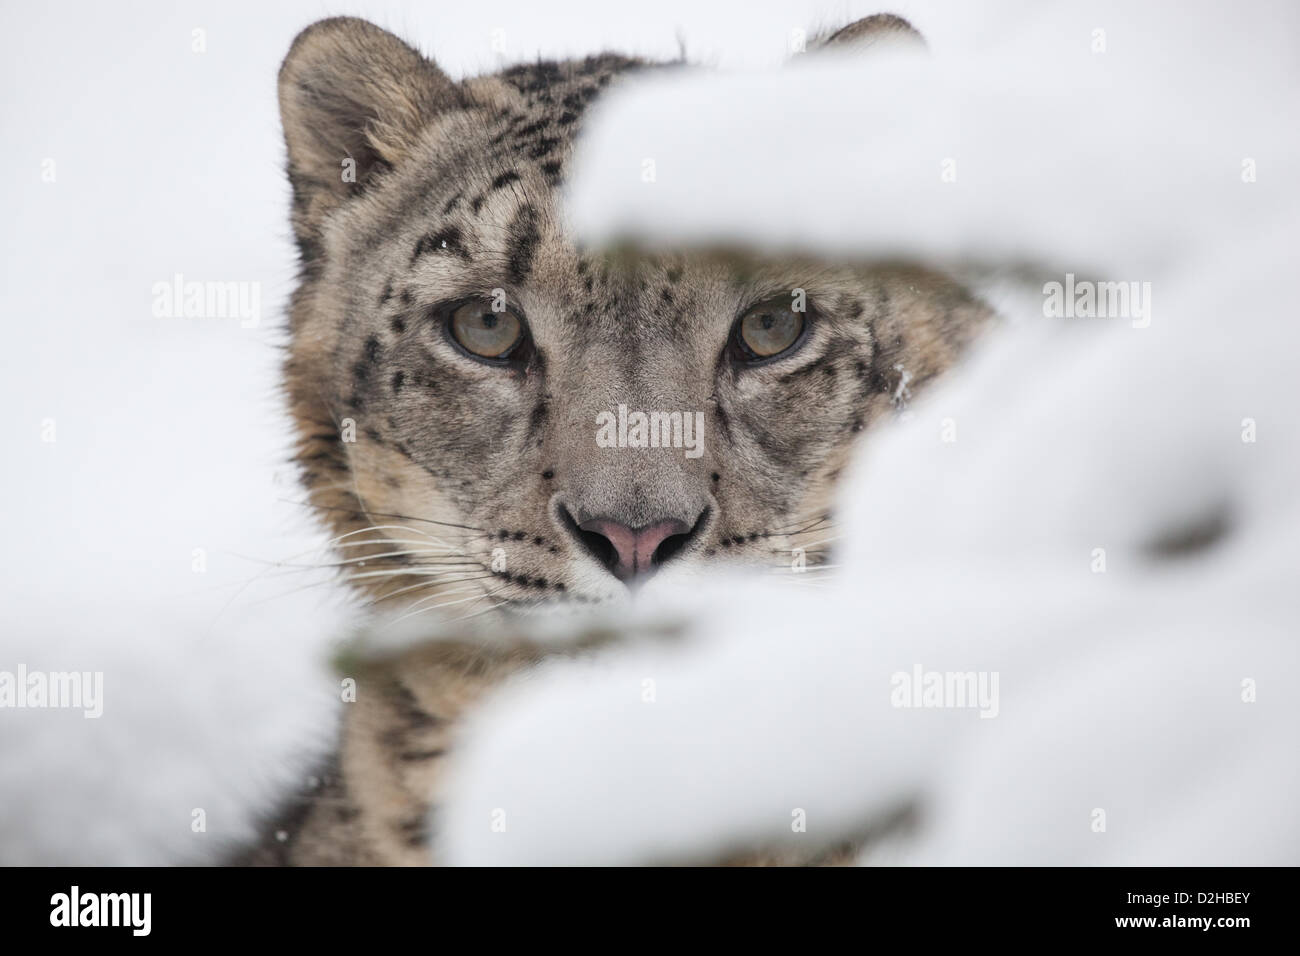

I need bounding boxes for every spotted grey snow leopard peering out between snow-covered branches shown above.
[237,14,992,865]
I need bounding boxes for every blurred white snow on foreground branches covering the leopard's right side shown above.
[437,4,1300,865]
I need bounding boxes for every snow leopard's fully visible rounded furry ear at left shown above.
[280,17,464,248]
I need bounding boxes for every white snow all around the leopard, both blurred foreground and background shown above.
[0,3,1300,864]
